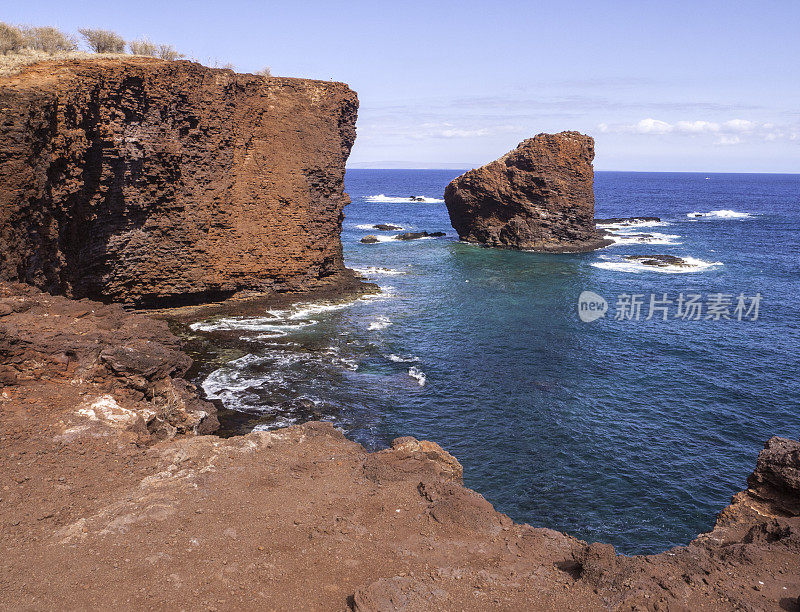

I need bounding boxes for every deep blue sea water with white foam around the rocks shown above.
[194,170,800,553]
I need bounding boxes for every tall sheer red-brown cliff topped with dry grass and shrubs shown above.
[0,58,358,306]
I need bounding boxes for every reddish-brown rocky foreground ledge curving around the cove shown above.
[0,284,800,611]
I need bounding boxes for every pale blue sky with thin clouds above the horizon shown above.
[7,0,800,172]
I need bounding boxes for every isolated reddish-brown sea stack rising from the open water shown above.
[444,132,611,253]
